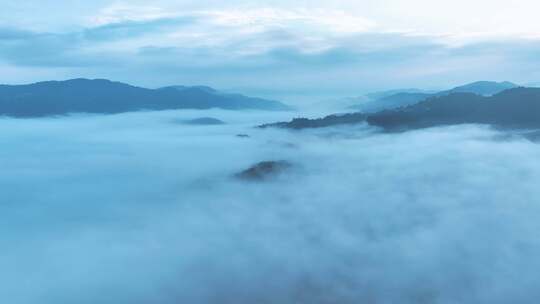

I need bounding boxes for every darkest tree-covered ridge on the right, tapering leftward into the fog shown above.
[261,88,540,131]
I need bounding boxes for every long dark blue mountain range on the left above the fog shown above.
[0,79,290,117]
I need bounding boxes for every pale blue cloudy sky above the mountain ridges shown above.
[0,0,540,101]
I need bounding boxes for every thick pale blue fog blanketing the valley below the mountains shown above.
[0,110,540,304]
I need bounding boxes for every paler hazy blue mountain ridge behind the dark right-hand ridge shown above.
[354,81,518,113]
